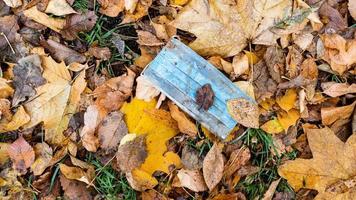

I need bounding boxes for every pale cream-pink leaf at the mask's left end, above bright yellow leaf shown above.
[136,76,160,101]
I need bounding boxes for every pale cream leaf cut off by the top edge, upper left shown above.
[45,0,76,16]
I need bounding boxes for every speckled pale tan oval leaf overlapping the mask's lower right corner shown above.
[227,98,260,128]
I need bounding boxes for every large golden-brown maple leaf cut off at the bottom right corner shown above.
[278,128,356,200]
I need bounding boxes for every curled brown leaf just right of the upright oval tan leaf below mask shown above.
[224,146,251,179]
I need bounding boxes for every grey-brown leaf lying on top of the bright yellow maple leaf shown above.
[116,135,147,173]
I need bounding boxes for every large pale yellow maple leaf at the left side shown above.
[24,56,86,145]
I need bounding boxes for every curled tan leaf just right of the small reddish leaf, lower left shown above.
[31,142,53,176]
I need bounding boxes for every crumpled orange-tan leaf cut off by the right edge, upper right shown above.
[321,34,356,74]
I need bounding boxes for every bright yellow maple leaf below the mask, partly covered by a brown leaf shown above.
[121,98,181,189]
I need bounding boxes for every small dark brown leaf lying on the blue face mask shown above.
[195,83,215,110]
